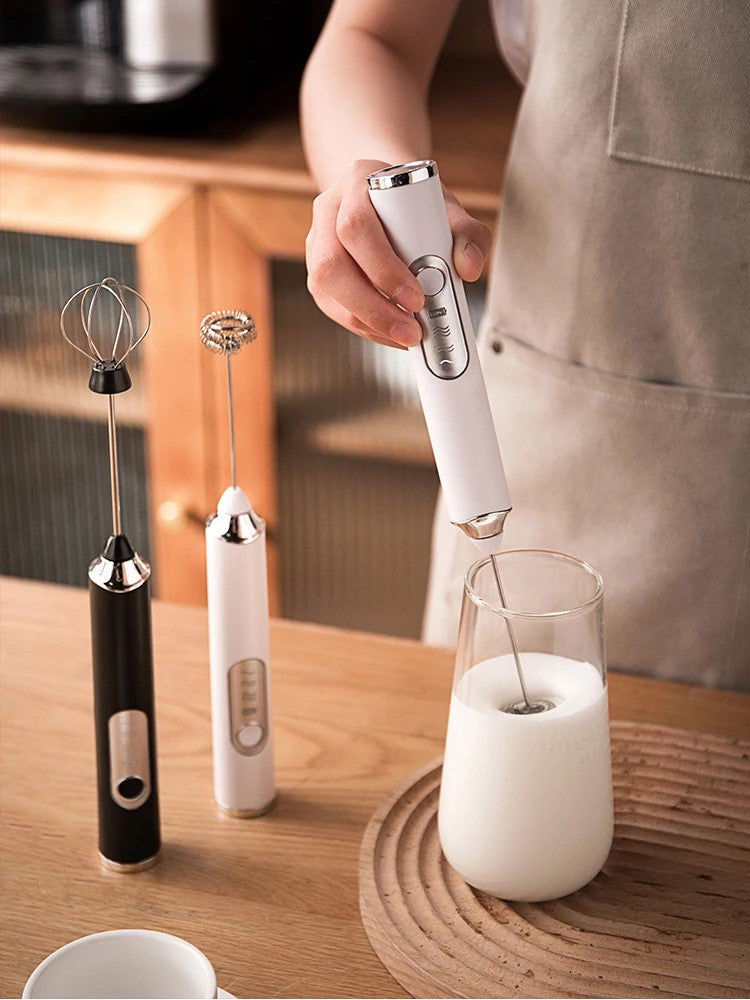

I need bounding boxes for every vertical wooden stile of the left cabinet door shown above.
[138,192,212,604]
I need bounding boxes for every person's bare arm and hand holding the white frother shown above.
[301,0,490,346]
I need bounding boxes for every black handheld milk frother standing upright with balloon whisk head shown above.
[60,278,161,872]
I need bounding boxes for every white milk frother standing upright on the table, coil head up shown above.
[200,311,276,817]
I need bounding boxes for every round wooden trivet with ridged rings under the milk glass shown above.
[360,723,750,997]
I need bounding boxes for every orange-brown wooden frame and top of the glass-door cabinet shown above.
[0,60,518,612]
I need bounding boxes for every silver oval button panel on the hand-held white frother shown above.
[410,254,469,379]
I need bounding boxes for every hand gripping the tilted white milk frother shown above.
[305,160,492,349]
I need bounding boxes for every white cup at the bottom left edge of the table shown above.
[23,930,216,1000]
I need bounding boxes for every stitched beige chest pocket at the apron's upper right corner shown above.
[608,0,750,181]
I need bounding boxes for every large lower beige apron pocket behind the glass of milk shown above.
[470,329,750,688]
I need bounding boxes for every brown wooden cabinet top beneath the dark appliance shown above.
[0,57,520,244]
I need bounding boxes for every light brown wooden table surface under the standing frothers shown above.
[0,579,750,997]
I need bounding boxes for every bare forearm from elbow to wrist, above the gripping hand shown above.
[301,21,430,189]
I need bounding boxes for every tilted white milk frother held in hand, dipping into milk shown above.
[367,160,547,714]
